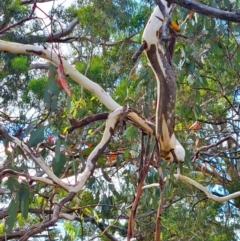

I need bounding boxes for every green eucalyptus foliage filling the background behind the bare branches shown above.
[0,0,240,241]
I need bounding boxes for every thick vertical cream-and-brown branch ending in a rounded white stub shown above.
[142,0,185,162]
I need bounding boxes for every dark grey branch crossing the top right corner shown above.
[167,0,240,23]
